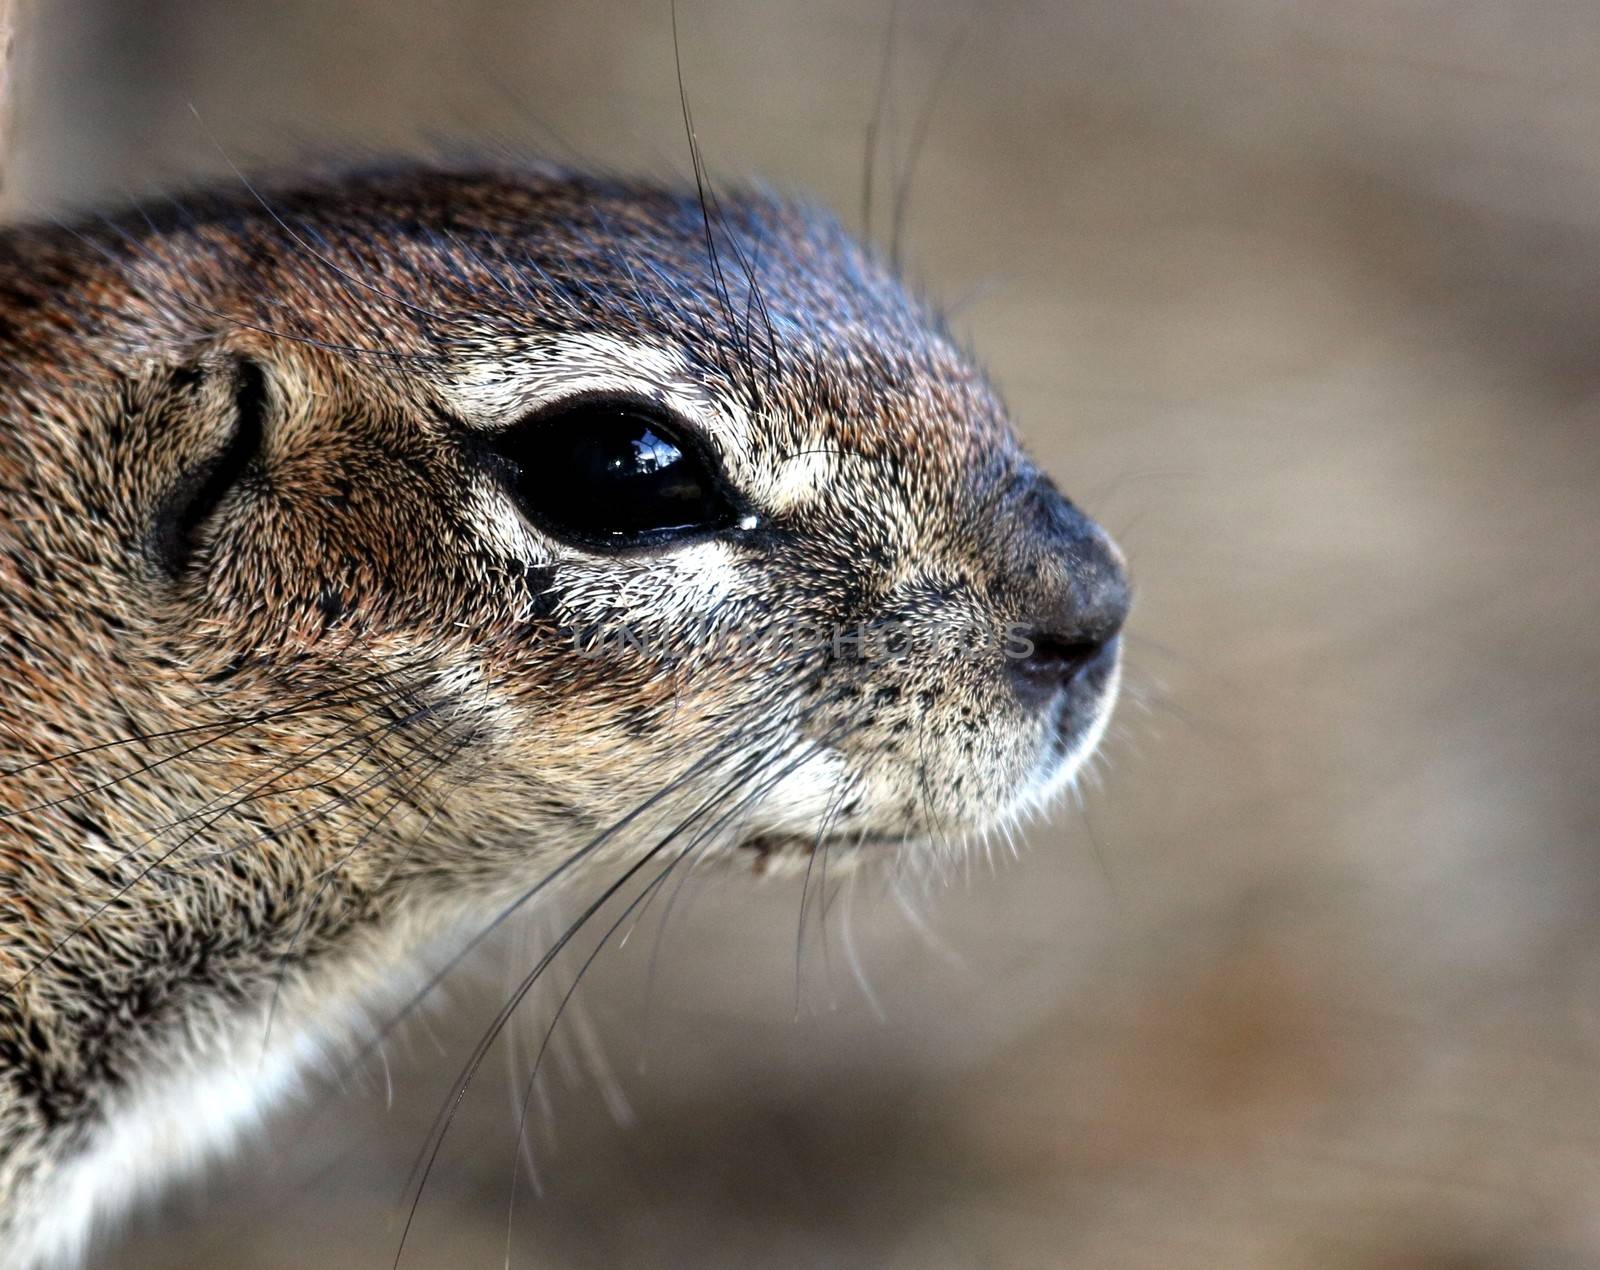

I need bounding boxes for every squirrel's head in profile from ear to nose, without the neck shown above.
[3,173,1128,885]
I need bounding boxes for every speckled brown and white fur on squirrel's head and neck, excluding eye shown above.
[0,168,1123,1264]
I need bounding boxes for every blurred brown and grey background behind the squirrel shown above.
[6,0,1600,1270]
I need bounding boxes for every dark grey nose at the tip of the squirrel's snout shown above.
[1006,477,1131,707]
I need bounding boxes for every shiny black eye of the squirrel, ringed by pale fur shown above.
[491,400,738,550]
